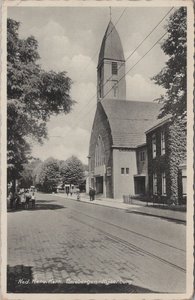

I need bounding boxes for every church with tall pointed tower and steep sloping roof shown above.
[88,21,161,198]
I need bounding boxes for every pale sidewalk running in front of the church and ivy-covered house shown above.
[55,193,186,223]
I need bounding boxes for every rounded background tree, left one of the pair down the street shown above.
[35,157,61,192]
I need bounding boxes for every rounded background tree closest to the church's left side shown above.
[60,156,84,185]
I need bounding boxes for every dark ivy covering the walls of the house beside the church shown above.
[147,118,186,205]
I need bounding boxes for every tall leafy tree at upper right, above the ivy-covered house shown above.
[153,7,187,120]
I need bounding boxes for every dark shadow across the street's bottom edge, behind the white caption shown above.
[7,265,158,294]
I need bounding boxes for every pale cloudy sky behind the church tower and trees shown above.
[8,6,173,163]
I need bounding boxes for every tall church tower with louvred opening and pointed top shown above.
[97,21,126,101]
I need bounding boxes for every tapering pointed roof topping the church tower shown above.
[98,21,125,65]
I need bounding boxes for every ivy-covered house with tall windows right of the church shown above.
[146,117,186,204]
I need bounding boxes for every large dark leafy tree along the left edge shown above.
[7,19,75,186]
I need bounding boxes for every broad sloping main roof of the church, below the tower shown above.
[101,99,162,148]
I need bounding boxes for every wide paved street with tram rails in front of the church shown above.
[7,193,186,293]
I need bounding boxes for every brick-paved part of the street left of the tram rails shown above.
[8,195,185,292]
